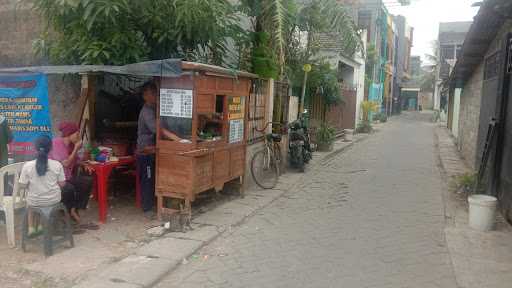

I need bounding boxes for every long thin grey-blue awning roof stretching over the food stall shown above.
[0,59,258,78]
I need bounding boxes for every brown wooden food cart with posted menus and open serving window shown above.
[156,62,257,217]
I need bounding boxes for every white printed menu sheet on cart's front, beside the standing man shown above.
[160,89,194,118]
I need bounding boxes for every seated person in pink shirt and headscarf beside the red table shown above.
[48,122,92,228]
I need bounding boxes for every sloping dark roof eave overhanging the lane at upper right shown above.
[450,0,512,85]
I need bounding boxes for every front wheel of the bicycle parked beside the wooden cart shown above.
[251,148,279,189]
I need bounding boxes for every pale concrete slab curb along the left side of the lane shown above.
[73,134,369,288]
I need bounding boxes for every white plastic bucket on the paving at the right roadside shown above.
[468,194,498,231]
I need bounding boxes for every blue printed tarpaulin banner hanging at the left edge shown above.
[0,74,52,155]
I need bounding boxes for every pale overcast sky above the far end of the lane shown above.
[384,0,478,58]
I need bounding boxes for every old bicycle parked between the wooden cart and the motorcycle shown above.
[251,122,282,189]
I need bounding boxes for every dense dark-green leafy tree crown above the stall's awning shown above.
[34,0,244,65]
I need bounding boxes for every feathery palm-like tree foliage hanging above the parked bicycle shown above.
[241,0,362,83]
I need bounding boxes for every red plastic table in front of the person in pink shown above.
[86,156,140,223]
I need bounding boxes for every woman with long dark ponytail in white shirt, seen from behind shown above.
[19,136,66,235]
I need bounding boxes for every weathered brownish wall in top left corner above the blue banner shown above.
[0,0,43,67]
